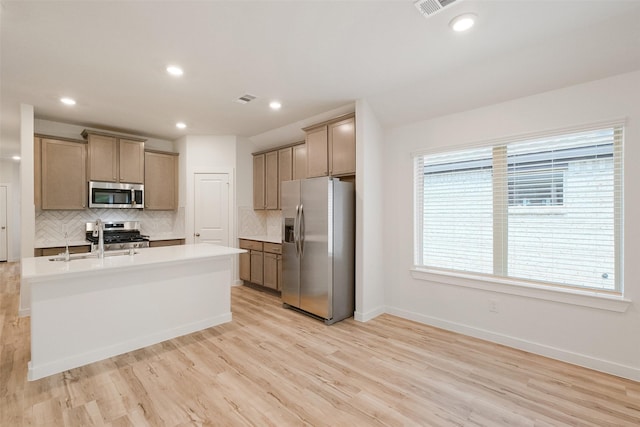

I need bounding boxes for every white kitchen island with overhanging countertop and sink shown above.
[21,243,245,380]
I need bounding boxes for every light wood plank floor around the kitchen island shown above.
[0,263,640,427]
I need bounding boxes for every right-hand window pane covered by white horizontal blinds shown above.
[507,130,615,290]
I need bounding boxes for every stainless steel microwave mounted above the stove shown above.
[89,181,144,209]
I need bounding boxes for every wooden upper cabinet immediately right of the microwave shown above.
[144,151,178,210]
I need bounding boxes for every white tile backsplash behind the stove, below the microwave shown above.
[35,208,184,247]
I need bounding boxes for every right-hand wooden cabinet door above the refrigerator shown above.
[328,117,356,176]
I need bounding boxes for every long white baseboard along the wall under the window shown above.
[384,307,640,381]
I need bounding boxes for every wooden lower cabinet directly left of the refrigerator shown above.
[239,239,282,291]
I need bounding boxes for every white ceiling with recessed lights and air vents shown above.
[0,0,640,156]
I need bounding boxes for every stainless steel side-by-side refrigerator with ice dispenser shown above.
[281,177,355,324]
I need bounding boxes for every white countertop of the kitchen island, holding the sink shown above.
[21,243,246,281]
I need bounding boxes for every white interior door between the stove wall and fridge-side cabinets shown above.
[193,173,229,246]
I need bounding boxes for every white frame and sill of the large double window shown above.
[411,120,630,311]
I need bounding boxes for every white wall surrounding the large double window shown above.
[382,71,640,380]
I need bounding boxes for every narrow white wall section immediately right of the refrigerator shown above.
[354,100,384,322]
